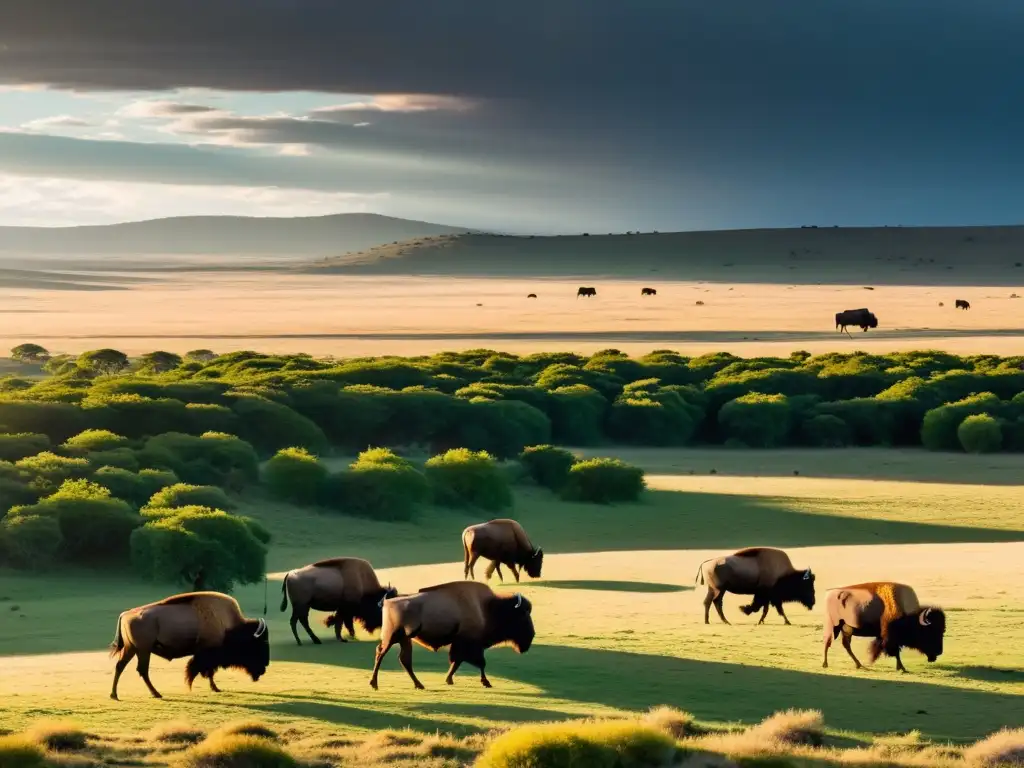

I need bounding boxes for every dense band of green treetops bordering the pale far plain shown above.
[0,345,1024,458]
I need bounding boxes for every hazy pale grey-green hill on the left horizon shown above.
[0,213,467,261]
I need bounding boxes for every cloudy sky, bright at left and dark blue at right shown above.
[0,0,1024,232]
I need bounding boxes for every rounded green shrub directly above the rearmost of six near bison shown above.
[426,449,512,511]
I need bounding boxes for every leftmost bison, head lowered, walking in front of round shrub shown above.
[111,592,270,699]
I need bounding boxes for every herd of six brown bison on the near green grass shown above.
[111,519,946,699]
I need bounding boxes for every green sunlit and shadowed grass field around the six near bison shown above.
[0,451,1024,757]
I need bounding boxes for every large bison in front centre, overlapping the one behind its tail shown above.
[370,582,535,690]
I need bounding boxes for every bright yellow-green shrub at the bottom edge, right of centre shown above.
[475,720,677,768]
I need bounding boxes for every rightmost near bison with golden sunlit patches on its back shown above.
[821,582,946,672]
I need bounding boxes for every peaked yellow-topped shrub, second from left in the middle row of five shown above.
[325,449,430,520]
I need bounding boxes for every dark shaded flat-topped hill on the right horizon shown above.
[302,226,1024,287]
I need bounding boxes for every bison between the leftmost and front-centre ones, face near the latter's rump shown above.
[281,557,398,645]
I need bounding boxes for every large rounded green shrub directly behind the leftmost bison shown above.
[131,507,266,591]
